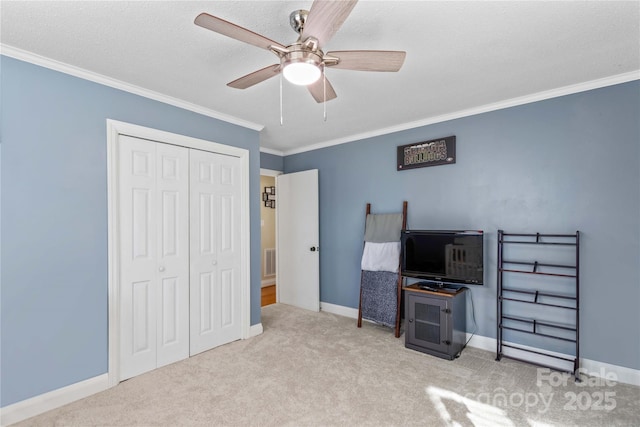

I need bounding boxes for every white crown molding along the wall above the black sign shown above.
[284,70,640,156]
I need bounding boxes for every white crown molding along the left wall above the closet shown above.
[0,43,264,132]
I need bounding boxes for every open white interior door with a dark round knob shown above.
[276,169,320,311]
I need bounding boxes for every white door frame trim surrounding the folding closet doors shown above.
[107,119,251,387]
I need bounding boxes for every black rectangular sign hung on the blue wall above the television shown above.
[398,136,456,171]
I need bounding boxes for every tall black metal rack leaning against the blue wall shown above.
[496,230,580,381]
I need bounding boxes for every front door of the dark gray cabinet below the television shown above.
[409,294,451,353]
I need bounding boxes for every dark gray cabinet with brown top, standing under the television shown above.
[404,285,467,360]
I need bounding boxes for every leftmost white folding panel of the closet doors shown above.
[119,136,157,380]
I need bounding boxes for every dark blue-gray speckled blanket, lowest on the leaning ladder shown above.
[361,270,398,328]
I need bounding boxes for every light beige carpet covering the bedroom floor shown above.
[17,304,640,427]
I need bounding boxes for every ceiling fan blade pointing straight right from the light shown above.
[327,50,407,71]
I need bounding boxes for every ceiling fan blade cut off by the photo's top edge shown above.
[300,0,358,47]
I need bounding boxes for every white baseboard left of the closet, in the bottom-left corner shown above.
[0,374,109,427]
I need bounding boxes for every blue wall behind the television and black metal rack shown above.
[284,81,640,369]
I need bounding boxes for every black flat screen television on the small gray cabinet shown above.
[401,230,484,287]
